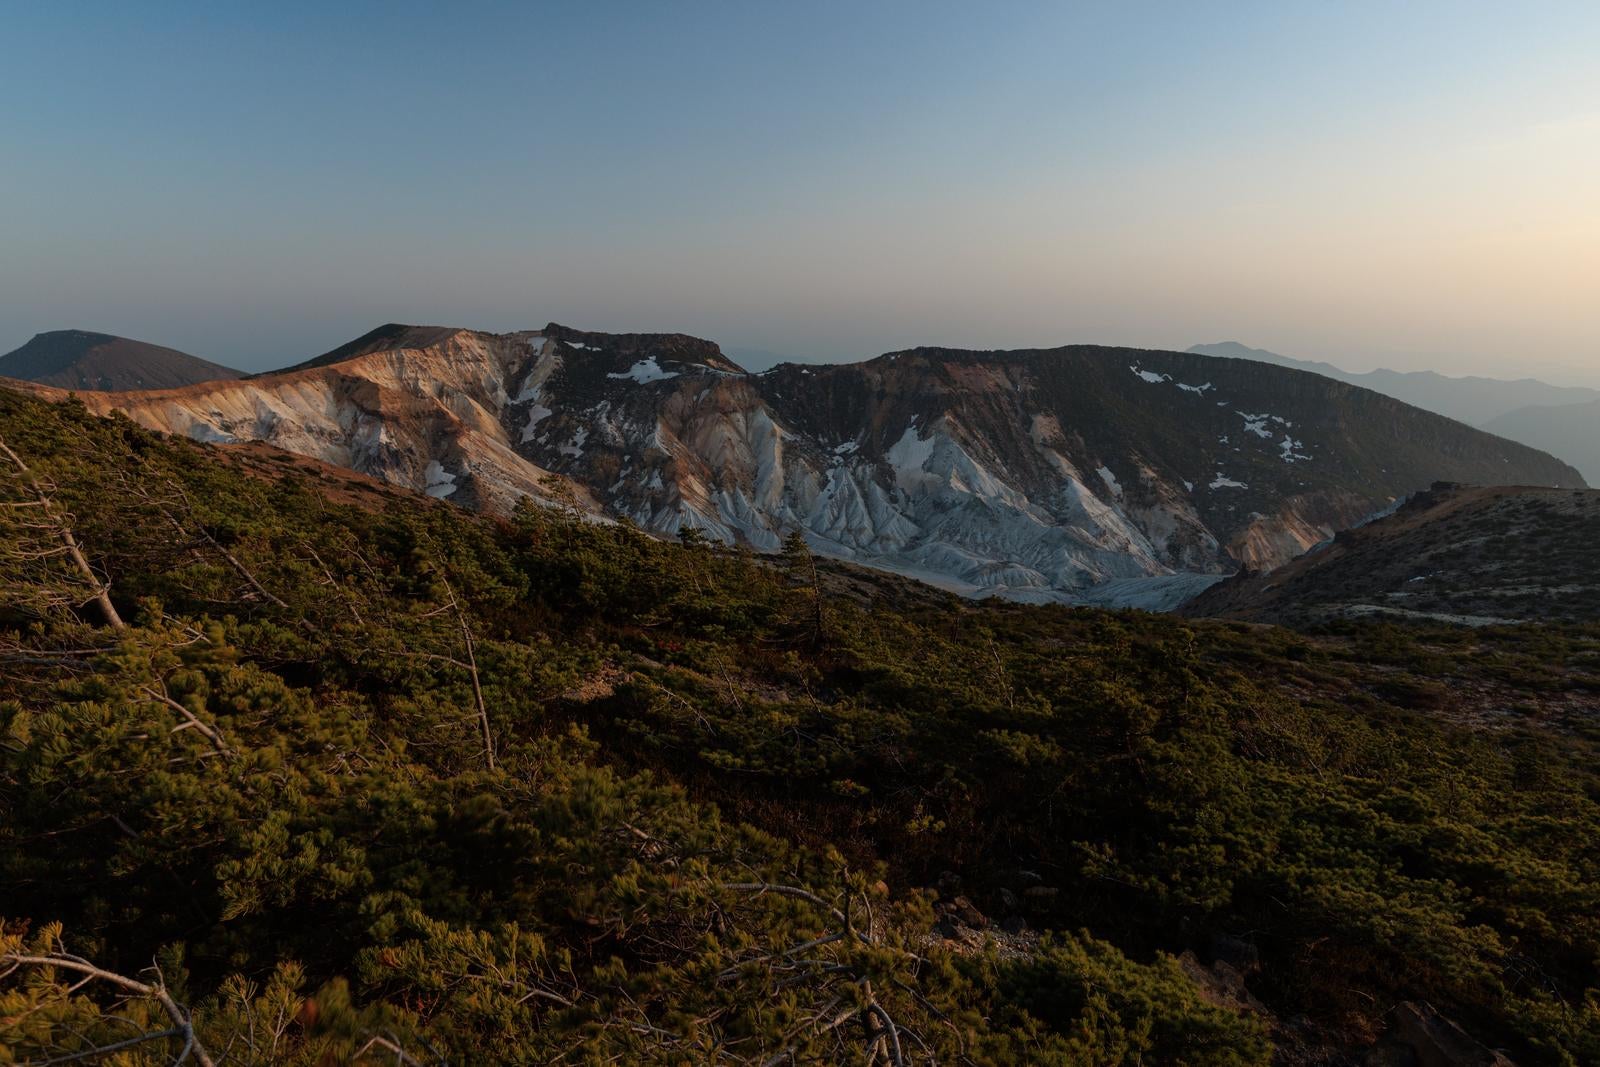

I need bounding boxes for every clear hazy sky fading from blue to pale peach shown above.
[0,0,1600,382]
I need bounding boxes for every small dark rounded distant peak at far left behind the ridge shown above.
[0,330,242,392]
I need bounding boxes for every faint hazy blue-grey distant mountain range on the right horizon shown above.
[1189,341,1600,428]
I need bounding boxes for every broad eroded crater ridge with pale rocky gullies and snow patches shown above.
[25,323,1581,606]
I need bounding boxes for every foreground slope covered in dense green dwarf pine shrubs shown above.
[0,392,1600,1065]
